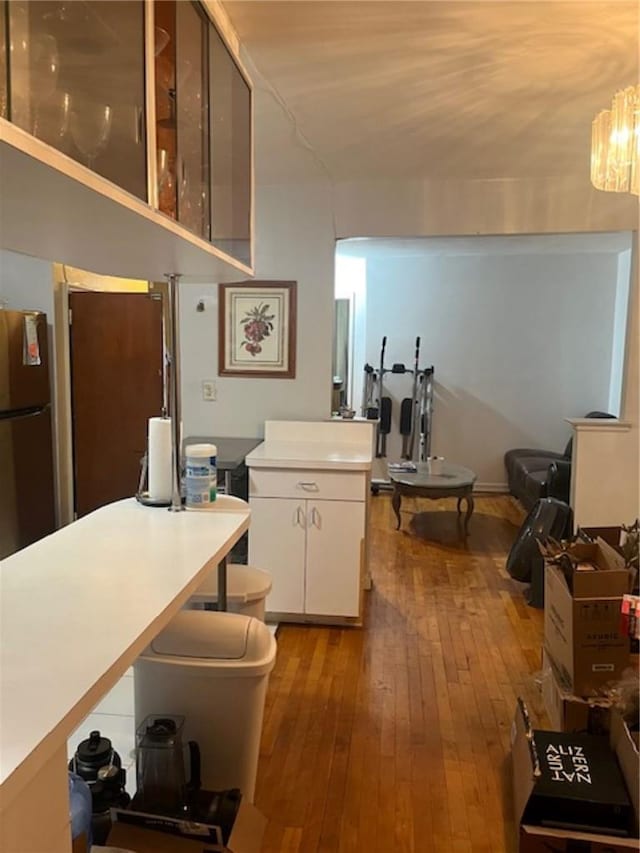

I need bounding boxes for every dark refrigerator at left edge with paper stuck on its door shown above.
[0,309,55,559]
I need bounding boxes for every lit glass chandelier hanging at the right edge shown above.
[591,85,640,195]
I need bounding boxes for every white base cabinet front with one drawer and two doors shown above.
[249,469,368,619]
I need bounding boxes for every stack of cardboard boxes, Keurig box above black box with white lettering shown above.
[512,538,640,853]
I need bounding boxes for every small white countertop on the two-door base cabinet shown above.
[245,441,371,471]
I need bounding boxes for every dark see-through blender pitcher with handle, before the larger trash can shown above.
[136,715,200,817]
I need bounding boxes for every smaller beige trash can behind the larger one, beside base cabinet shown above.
[186,563,271,622]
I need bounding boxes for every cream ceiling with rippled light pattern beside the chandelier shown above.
[224,0,639,181]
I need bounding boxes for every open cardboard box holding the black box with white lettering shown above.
[511,708,640,853]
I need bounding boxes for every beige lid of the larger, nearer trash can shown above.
[151,610,271,663]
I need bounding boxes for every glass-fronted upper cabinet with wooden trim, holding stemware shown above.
[0,0,252,274]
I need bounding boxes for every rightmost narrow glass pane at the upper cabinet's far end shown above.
[209,27,251,264]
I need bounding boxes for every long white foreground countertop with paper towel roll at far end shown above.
[0,498,250,805]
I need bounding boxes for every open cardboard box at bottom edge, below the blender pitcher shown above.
[107,799,267,853]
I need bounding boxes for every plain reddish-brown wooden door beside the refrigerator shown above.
[69,291,162,517]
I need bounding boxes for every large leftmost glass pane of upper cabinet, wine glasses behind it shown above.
[9,0,147,199]
